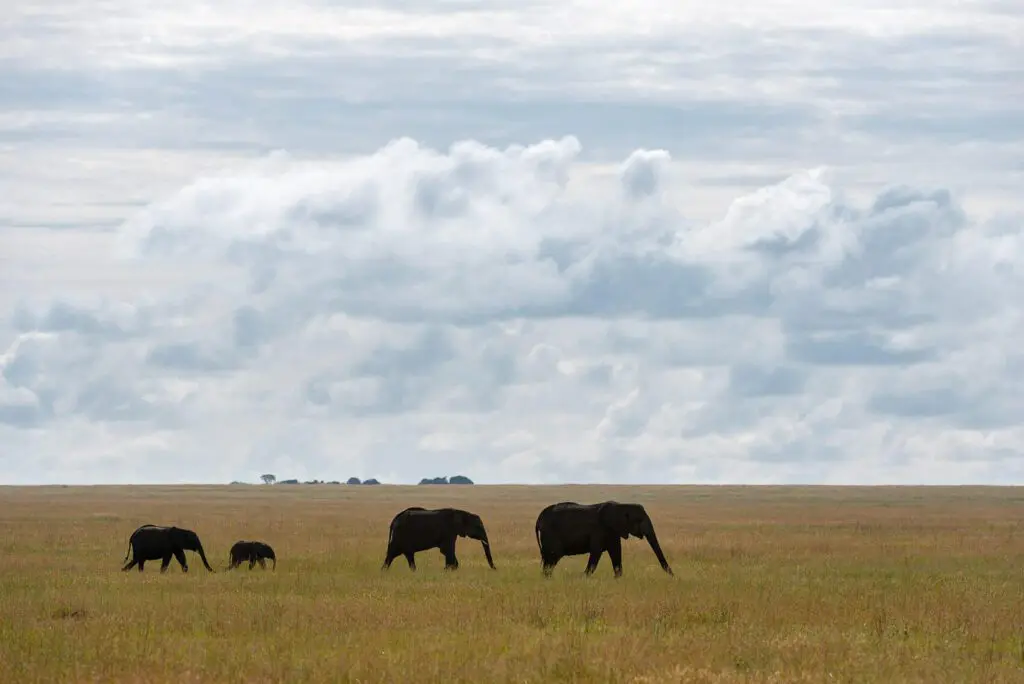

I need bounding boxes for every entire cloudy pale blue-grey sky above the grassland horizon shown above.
[0,0,1024,483]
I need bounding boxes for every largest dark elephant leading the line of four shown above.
[535,501,673,578]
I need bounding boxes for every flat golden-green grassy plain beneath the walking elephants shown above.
[0,485,1024,684]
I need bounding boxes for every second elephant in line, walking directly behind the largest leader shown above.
[381,506,498,571]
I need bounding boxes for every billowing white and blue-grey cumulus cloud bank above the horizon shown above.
[0,136,1024,482]
